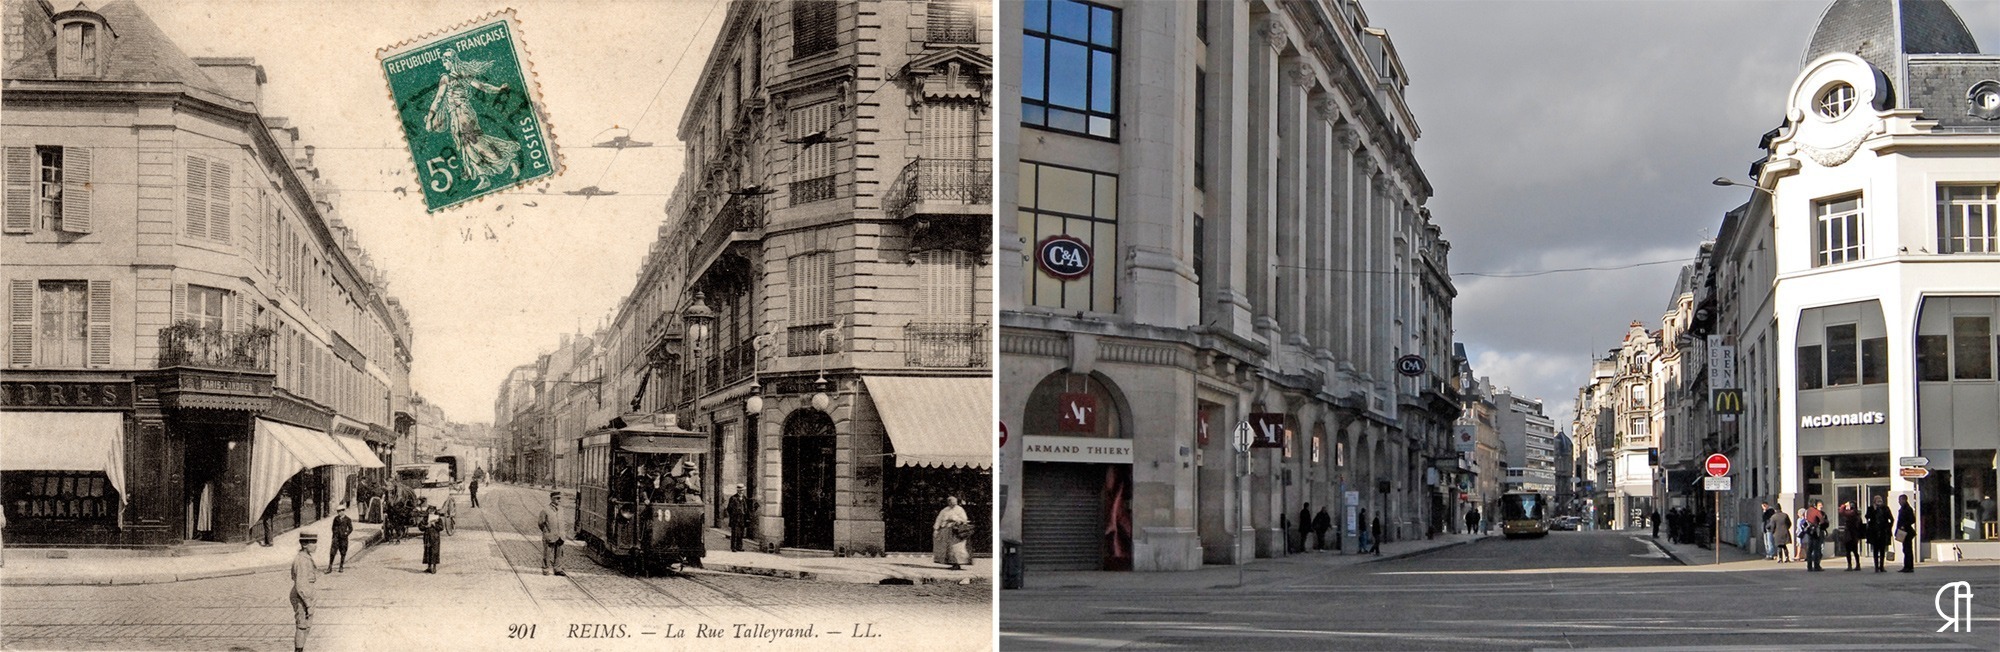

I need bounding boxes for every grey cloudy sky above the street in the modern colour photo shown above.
[1362,0,2000,426]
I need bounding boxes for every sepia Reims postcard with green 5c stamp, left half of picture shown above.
[0,0,996,650]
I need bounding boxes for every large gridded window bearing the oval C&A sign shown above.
[1016,162,1118,312]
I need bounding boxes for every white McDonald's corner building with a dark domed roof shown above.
[1720,0,2000,558]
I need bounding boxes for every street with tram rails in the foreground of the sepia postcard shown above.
[0,488,992,650]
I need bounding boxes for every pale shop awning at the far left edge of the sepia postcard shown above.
[0,412,130,502]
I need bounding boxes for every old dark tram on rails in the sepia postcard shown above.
[576,414,708,574]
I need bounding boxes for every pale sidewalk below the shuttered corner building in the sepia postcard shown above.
[0,516,382,586]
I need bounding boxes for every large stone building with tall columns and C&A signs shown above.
[998,0,1464,578]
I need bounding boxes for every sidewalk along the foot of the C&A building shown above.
[1008,534,1500,592]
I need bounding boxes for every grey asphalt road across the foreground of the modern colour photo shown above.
[1000,532,2000,650]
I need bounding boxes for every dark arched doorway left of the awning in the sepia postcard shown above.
[780,410,836,550]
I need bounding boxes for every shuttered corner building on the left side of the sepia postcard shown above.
[0,0,410,548]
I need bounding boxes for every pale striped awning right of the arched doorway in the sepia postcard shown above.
[862,376,998,468]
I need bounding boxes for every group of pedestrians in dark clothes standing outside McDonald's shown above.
[1764,496,1916,572]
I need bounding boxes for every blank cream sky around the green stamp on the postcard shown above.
[143,0,724,422]
